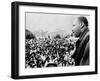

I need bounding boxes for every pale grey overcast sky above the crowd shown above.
[26,13,89,32]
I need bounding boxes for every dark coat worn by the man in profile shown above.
[72,28,89,65]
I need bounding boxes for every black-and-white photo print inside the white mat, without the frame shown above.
[25,12,90,69]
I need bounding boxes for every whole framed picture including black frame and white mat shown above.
[11,2,97,79]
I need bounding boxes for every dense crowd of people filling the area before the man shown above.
[25,34,79,68]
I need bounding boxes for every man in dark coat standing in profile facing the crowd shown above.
[72,16,89,66]
